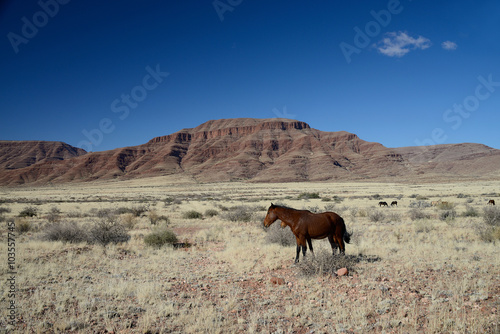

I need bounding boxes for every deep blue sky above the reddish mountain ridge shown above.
[0,0,500,151]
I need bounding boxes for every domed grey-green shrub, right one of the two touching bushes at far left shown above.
[87,219,130,246]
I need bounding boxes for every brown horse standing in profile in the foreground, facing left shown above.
[264,203,351,263]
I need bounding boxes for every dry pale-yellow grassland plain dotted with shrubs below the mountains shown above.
[0,179,500,333]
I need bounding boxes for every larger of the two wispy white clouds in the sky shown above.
[377,31,431,57]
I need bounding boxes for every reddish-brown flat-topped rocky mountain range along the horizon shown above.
[0,118,500,185]
